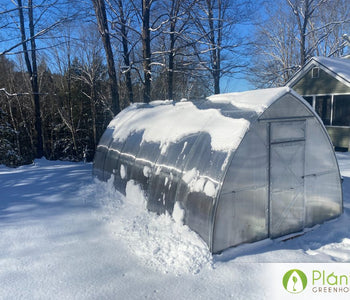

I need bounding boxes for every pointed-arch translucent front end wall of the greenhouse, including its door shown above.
[212,94,342,252]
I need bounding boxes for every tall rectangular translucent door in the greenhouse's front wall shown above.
[269,121,305,238]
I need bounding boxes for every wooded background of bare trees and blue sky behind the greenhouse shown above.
[0,0,349,166]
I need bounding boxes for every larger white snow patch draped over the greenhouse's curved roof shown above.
[108,101,250,153]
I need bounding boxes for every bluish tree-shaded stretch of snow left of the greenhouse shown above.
[0,160,91,223]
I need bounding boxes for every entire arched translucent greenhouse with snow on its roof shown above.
[94,87,343,253]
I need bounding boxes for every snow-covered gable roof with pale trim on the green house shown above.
[286,56,350,86]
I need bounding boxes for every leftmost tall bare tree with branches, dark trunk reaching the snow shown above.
[0,0,82,158]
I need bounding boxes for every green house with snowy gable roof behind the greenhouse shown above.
[287,57,350,151]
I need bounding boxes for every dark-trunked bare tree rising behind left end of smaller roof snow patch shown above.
[193,0,254,94]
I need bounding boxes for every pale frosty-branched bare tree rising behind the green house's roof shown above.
[248,0,350,87]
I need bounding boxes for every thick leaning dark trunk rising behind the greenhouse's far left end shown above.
[92,0,120,115]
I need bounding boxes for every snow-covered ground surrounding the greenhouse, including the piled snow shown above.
[0,153,350,300]
